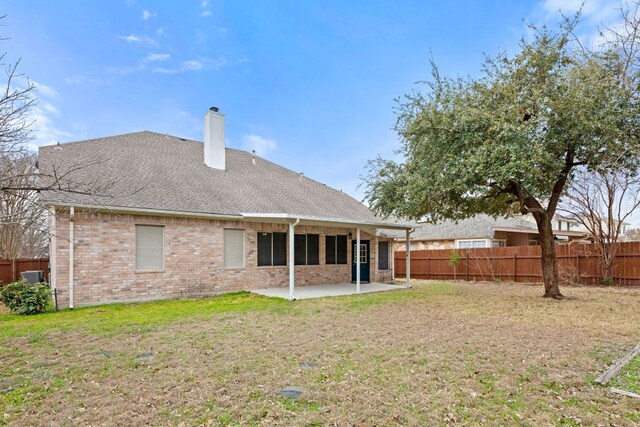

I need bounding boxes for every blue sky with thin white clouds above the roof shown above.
[0,0,617,199]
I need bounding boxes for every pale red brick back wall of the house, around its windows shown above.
[51,210,393,307]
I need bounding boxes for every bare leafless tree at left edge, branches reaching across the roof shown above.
[0,16,122,258]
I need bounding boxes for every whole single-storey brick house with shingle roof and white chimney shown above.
[39,108,410,307]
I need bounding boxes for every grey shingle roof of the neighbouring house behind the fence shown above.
[411,215,538,240]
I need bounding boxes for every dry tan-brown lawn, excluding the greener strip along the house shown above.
[0,281,640,426]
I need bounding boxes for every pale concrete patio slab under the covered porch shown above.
[251,283,407,299]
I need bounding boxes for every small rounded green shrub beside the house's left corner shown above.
[0,280,51,314]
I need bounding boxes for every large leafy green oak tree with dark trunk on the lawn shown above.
[364,21,640,298]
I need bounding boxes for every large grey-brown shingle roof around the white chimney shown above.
[39,131,381,222]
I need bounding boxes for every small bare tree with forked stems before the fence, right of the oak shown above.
[558,164,640,283]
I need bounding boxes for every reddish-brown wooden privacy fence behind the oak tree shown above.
[394,242,640,286]
